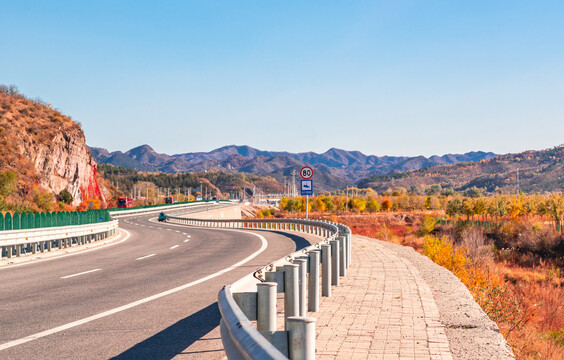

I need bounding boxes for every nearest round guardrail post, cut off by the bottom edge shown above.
[286,316,317,360]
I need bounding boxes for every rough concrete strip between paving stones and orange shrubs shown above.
[355,235,515,360]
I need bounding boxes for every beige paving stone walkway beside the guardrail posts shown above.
[308,236,452,360]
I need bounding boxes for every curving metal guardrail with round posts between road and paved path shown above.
[167,216,351,360]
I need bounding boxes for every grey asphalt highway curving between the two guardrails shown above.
[0,214,313,359]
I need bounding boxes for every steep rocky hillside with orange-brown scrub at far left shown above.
[0,85,105,209]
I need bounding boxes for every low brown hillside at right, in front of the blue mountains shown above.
[359,145,564,194]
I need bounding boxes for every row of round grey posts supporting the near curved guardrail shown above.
[233,229,351,359]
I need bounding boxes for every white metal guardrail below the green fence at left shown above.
[0,220,118,258]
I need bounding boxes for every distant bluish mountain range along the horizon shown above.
[90,145,497,191]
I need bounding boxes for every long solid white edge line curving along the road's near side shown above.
[0,230,268,351]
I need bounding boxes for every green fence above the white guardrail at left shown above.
[0,209,110,231]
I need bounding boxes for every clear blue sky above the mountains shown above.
[0,0,564,155]
